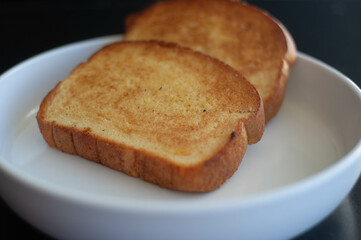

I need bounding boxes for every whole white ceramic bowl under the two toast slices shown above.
[0,36,361,239]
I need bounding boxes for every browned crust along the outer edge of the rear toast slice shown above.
[125,0,297,123]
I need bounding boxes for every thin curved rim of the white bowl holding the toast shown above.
[0,35,361,215]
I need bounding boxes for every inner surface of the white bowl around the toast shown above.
[0,37,361,206]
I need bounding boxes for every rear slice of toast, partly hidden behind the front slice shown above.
[125,0,296,121]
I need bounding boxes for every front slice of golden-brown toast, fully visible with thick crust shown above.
[37,41,264,192]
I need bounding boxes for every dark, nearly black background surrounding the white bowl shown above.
[0,0,361,240]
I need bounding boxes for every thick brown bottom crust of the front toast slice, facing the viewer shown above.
[37,117,247,192]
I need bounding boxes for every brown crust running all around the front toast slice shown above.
[37,41,264,192]
